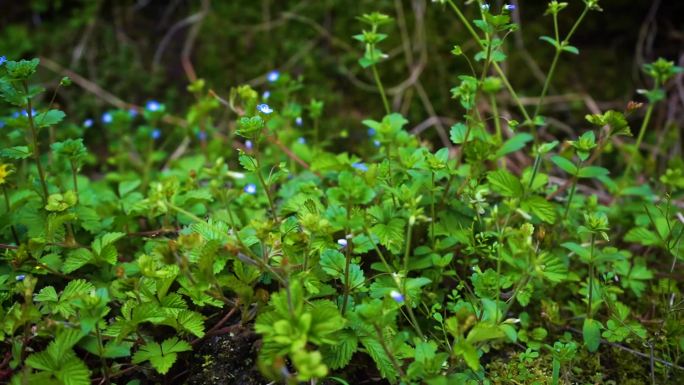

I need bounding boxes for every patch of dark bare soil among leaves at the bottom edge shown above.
[186,329,268,385]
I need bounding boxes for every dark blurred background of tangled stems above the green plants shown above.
[0,0,684,143]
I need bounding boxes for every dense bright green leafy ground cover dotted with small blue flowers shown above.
[0,0,684,385]
